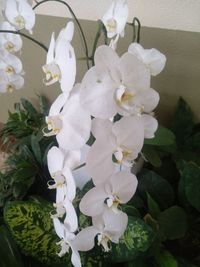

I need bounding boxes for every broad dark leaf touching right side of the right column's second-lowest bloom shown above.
[138,169,174,209]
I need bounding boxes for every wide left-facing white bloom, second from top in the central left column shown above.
[45,85,91,150]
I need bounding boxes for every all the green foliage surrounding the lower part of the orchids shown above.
[0,99,200,267]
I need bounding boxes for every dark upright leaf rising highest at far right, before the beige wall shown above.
[171,98,194,146]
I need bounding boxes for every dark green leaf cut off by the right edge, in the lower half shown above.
[182,162,200,211]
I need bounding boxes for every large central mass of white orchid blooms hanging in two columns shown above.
[43,0,166,267]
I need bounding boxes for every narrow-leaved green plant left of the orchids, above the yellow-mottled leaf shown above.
[0,96,55,207]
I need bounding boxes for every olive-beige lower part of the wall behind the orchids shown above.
[0,16,200,126]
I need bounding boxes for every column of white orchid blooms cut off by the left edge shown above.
[0,0,35,93]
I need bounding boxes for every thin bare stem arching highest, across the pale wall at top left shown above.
[33,0,90,69]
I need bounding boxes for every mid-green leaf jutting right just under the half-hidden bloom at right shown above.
[144,126,175,146]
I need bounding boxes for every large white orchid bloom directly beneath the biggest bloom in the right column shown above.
[86,116,144,184]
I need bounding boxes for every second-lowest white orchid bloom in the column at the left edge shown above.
[0,49,23,75]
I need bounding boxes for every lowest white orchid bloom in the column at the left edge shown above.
[0,70,24,93]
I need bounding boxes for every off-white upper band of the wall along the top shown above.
[34,0,200,32]
